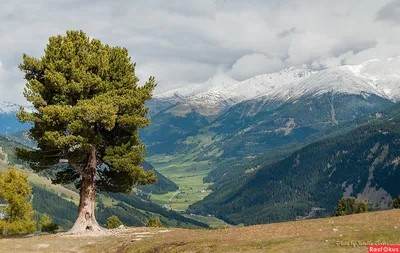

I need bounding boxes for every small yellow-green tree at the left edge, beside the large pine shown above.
[0,168,36,235]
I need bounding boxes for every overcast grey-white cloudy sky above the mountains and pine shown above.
[0,0,400,103]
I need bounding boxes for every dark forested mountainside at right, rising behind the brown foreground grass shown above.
[191,104,400,224]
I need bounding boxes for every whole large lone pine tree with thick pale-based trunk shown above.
[16,31,156,233]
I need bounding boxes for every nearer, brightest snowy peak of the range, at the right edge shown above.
[262,57,400,101]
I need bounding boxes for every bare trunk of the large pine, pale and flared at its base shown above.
[69,148,103,234]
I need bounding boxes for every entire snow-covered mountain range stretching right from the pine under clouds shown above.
[155,57,400,111]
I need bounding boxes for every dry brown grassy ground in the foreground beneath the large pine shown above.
[0,210,400,253]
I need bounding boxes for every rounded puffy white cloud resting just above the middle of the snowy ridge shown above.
[229,54,284,80]
